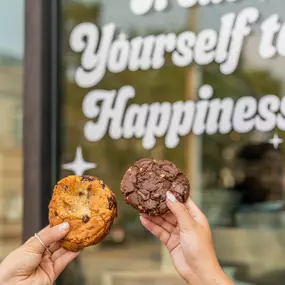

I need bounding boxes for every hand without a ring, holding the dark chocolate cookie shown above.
[140,192,233,285]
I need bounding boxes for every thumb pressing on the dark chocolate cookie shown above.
[166,191,196,231]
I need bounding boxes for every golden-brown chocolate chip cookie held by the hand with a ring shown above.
[49,175,117,251]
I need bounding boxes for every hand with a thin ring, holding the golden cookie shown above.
[0,223,79,285]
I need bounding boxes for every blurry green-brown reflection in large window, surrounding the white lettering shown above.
[61,0,285,285]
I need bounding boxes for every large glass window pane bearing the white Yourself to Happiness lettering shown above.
[58,0,285,285]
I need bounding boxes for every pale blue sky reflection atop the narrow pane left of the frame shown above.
[0,0,24,58]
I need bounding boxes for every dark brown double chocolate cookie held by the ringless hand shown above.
[121,158,190,216]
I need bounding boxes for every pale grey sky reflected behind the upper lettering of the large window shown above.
[101,0,285,91]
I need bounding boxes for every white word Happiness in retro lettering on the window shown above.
[83,85,285,149]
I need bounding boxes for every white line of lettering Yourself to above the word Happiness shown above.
[70,7,285,88]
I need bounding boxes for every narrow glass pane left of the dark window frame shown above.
[0,0,24,260]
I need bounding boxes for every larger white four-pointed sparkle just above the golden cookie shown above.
[62,147,97,176]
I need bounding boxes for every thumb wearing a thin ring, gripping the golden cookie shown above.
[23,222,70,254]
